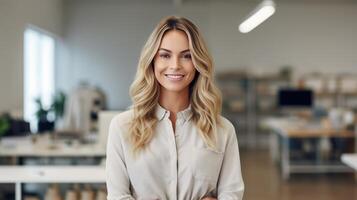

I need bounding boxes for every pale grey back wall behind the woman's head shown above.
[46,0,357,109]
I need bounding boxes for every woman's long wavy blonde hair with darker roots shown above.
[129,16,222,152]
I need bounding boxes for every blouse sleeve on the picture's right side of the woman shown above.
[218,124,244,200]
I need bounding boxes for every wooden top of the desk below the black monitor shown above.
[263,118,355,138]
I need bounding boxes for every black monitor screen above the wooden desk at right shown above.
[278,88,313,107]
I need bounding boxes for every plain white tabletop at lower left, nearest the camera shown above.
[0,165,105,183]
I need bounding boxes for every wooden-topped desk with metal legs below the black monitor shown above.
[262,118,357,179]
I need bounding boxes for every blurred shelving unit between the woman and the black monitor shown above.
[216,71,290,148]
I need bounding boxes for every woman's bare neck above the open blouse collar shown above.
[159,90,190,115]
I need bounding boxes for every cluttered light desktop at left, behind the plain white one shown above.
[0,136,106,157]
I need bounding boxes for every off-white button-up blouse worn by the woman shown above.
[106,105,244,200]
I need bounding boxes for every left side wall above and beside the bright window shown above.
[0,0,63,113]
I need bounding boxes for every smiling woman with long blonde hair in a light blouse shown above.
[106,17,244,200]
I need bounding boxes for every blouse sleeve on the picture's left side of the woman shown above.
[106,118,134,200]
